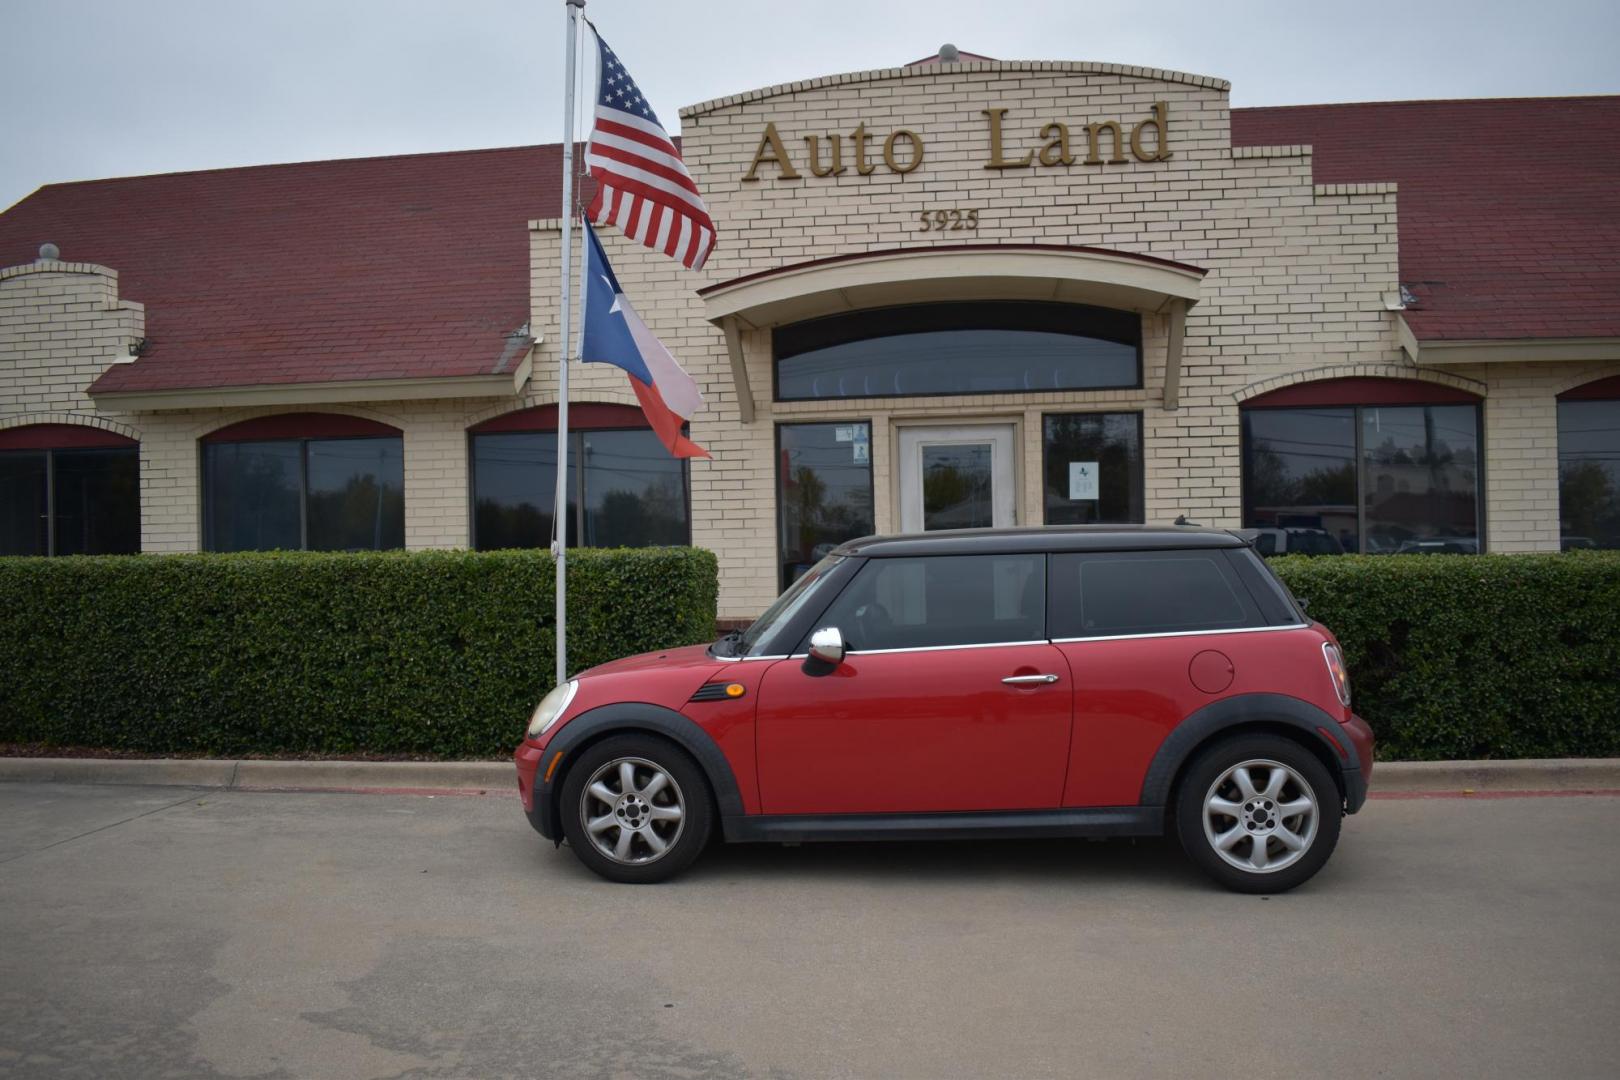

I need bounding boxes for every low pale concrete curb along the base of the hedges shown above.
[0,758,1620,795]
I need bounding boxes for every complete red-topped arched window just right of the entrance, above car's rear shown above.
[1243,379,1484,554]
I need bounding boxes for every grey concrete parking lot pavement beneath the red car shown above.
[0,784,1620,1080]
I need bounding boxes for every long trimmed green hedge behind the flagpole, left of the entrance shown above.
[0,547,718,758]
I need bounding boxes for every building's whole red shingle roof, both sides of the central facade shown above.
[0,97,1620,390]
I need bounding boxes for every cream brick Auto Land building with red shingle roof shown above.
[0,53,1620,619]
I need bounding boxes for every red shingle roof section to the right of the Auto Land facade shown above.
[1231,97,1620,340]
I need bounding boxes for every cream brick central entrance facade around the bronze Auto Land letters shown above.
[533,63,1405,615]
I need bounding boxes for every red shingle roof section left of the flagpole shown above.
[0,146,596,392]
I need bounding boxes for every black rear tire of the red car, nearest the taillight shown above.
[1175,735,1343,894]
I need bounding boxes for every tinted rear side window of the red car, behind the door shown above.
[1050,551,1265,638]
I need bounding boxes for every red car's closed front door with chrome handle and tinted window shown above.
[757,554,1071,814]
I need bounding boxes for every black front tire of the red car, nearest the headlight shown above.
[557,733,714,884]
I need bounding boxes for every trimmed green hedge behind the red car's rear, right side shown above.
[1270,552,1620,759]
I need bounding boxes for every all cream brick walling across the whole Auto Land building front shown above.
[0,63,1620,617]
